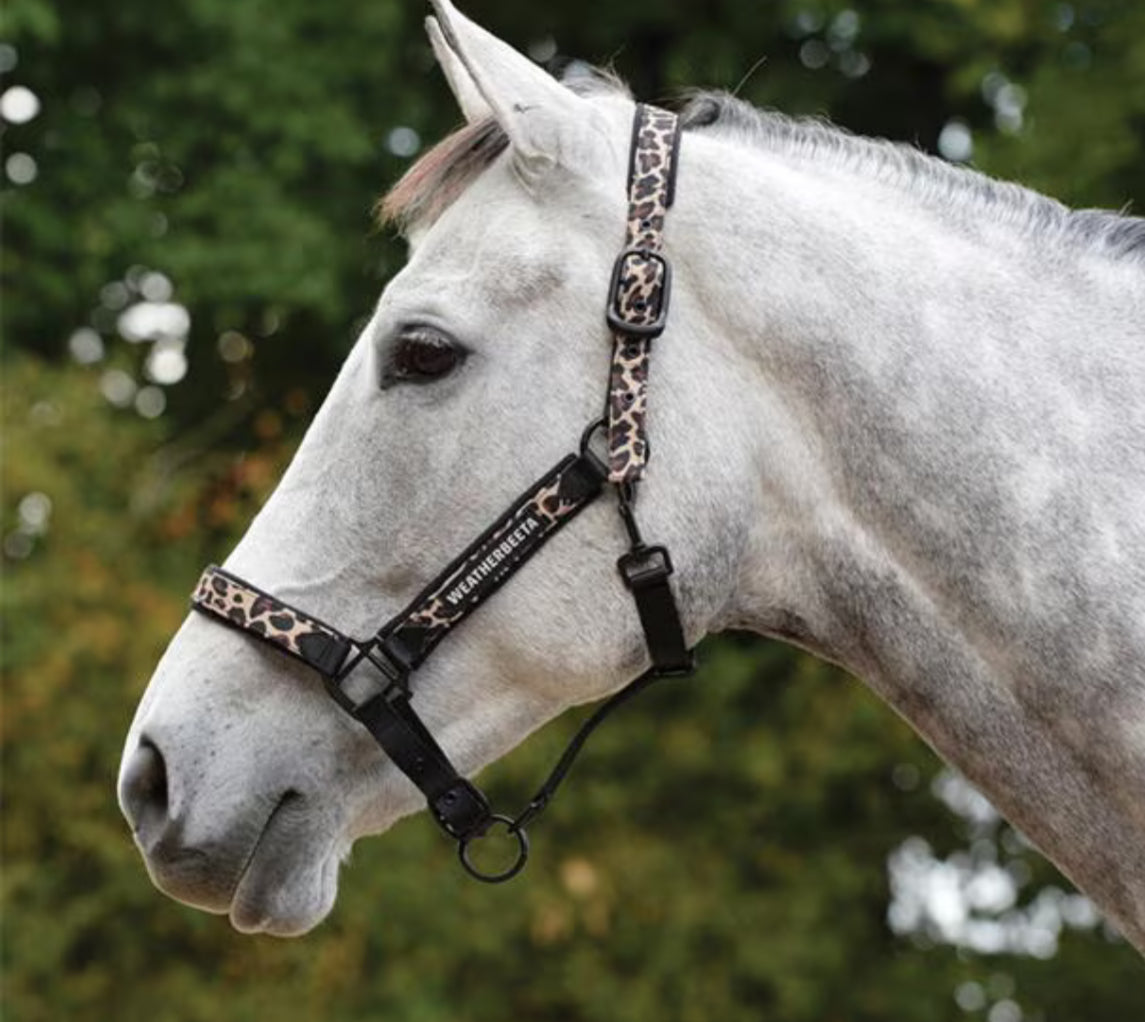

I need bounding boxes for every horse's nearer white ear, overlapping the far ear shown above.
[427,0,591,173]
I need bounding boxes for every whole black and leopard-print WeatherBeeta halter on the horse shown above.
[191,104,694,882]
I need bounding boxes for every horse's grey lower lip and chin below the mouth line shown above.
[229,795,342,937]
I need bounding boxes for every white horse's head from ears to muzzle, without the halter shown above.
[120,3,749,934]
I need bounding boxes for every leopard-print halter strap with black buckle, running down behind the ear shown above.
[606,104,679,484]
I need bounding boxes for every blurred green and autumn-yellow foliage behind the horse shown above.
[0,0,1145,1022]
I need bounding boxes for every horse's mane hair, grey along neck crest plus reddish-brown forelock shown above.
[376,70,1145,261]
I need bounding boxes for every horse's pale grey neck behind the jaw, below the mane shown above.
[671,129,1145,944]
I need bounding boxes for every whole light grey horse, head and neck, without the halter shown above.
[119,0,1145,950]
